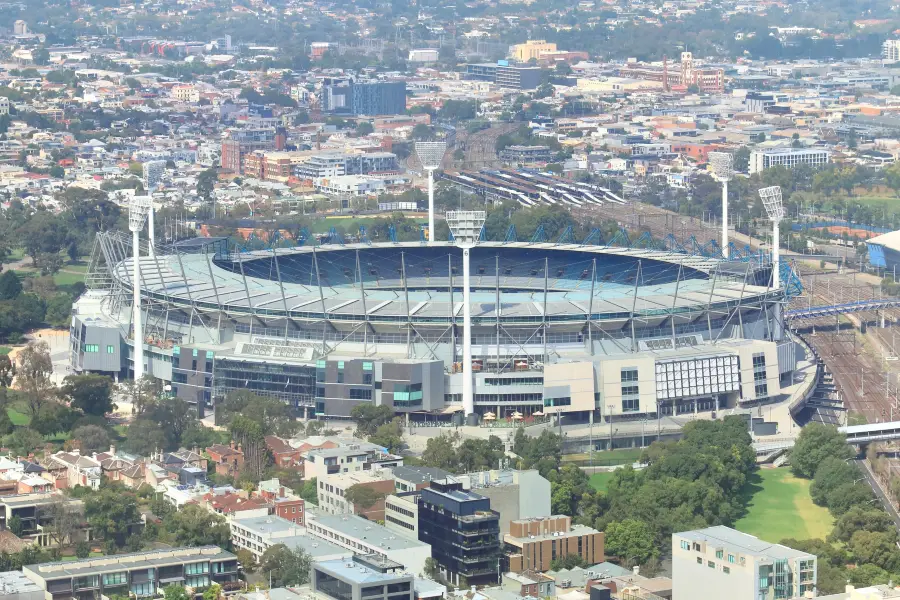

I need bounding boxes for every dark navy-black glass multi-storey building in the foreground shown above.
[419,478,500,587]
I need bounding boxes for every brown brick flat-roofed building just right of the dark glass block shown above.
[503,515,604,573]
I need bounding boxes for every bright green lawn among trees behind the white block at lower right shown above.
[734,467,834,543]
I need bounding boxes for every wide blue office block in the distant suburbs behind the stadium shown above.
[320,81,406,116]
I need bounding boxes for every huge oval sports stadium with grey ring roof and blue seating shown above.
[71,226,795,422]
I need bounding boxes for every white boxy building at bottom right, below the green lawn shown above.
[672,525,816,600]
